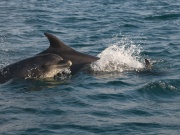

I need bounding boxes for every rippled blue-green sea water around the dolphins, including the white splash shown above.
[0,0,180,135]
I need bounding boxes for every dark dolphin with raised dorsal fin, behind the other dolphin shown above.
[39,33,99,74]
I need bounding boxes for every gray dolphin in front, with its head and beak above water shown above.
[0,54,72,84]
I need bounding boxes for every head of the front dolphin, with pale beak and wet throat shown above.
[28,54,72,78]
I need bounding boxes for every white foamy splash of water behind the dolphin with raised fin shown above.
[90,35,144,72]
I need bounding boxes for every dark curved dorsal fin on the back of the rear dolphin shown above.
[44,32,73,51]
